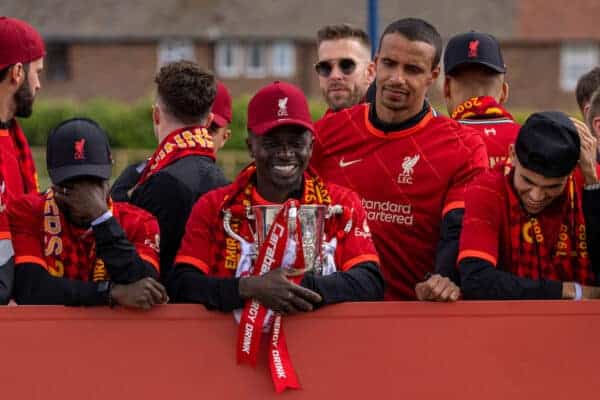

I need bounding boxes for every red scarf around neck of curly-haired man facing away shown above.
[137,126,215,186]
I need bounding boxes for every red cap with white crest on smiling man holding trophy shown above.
[248,81,315,135]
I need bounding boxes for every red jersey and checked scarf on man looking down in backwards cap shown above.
[458,170,595,284]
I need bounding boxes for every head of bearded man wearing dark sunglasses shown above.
[315,24,375,113]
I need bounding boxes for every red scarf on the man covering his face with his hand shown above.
[44,189,114,282]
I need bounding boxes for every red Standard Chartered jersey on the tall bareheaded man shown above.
[311,104,488,300]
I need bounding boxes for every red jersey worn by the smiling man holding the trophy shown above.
[175,180,379,278]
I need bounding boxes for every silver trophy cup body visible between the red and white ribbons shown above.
[252,204,327,276]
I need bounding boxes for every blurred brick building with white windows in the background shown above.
[1,0,600,109]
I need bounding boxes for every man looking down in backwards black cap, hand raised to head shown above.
[458,112,600,300]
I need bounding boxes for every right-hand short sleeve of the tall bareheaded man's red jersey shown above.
[442,127,489,216]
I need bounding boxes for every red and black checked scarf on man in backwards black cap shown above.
[504,170,594,284]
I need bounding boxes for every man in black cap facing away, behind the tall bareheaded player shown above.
[444,32,519,167]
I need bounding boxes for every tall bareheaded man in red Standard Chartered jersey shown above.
[311,18,488,301]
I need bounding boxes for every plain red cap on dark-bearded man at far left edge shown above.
[0,17,46,69]
